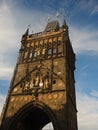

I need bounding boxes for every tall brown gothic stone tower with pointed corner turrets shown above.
[0,20,77,130]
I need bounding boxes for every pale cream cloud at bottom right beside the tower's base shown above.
[77,92,98,130]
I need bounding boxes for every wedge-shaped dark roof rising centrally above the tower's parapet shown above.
[44,20,60,32]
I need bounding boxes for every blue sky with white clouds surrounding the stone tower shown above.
[0,0,98,130]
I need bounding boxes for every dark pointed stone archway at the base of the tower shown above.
[9,102,58,130]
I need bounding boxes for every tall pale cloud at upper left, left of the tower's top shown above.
[0,3,17,53]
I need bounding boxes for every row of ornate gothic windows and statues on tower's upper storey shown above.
[19,37,63,63]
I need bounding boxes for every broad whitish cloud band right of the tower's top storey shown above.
[69,26,98,53]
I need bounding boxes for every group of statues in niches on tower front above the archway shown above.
[21,69,51,93]
